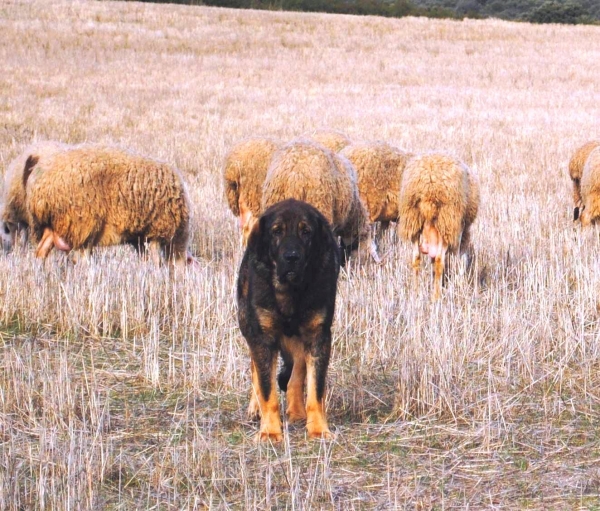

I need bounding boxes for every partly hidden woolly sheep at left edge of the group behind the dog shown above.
[223,138,281,246]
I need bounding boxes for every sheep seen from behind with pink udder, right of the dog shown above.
[398,154,479,300]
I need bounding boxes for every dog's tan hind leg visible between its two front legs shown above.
[279,337,306,422]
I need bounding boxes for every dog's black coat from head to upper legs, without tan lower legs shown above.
[237,199,340,436]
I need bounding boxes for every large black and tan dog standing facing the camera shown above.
[237,199,340,441]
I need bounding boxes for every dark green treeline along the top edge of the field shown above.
[131,0,600,24]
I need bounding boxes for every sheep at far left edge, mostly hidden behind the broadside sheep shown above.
[2,141,68,250]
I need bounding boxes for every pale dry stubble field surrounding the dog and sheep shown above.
[0,1,600,510]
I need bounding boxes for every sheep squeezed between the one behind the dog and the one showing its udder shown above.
[340,142,413,247]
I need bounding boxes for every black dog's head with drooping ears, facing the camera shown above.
[248,199,339,287]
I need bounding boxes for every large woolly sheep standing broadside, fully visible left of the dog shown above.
[23,145,194,263]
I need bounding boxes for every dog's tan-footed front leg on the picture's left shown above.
[250,344,283,442]
